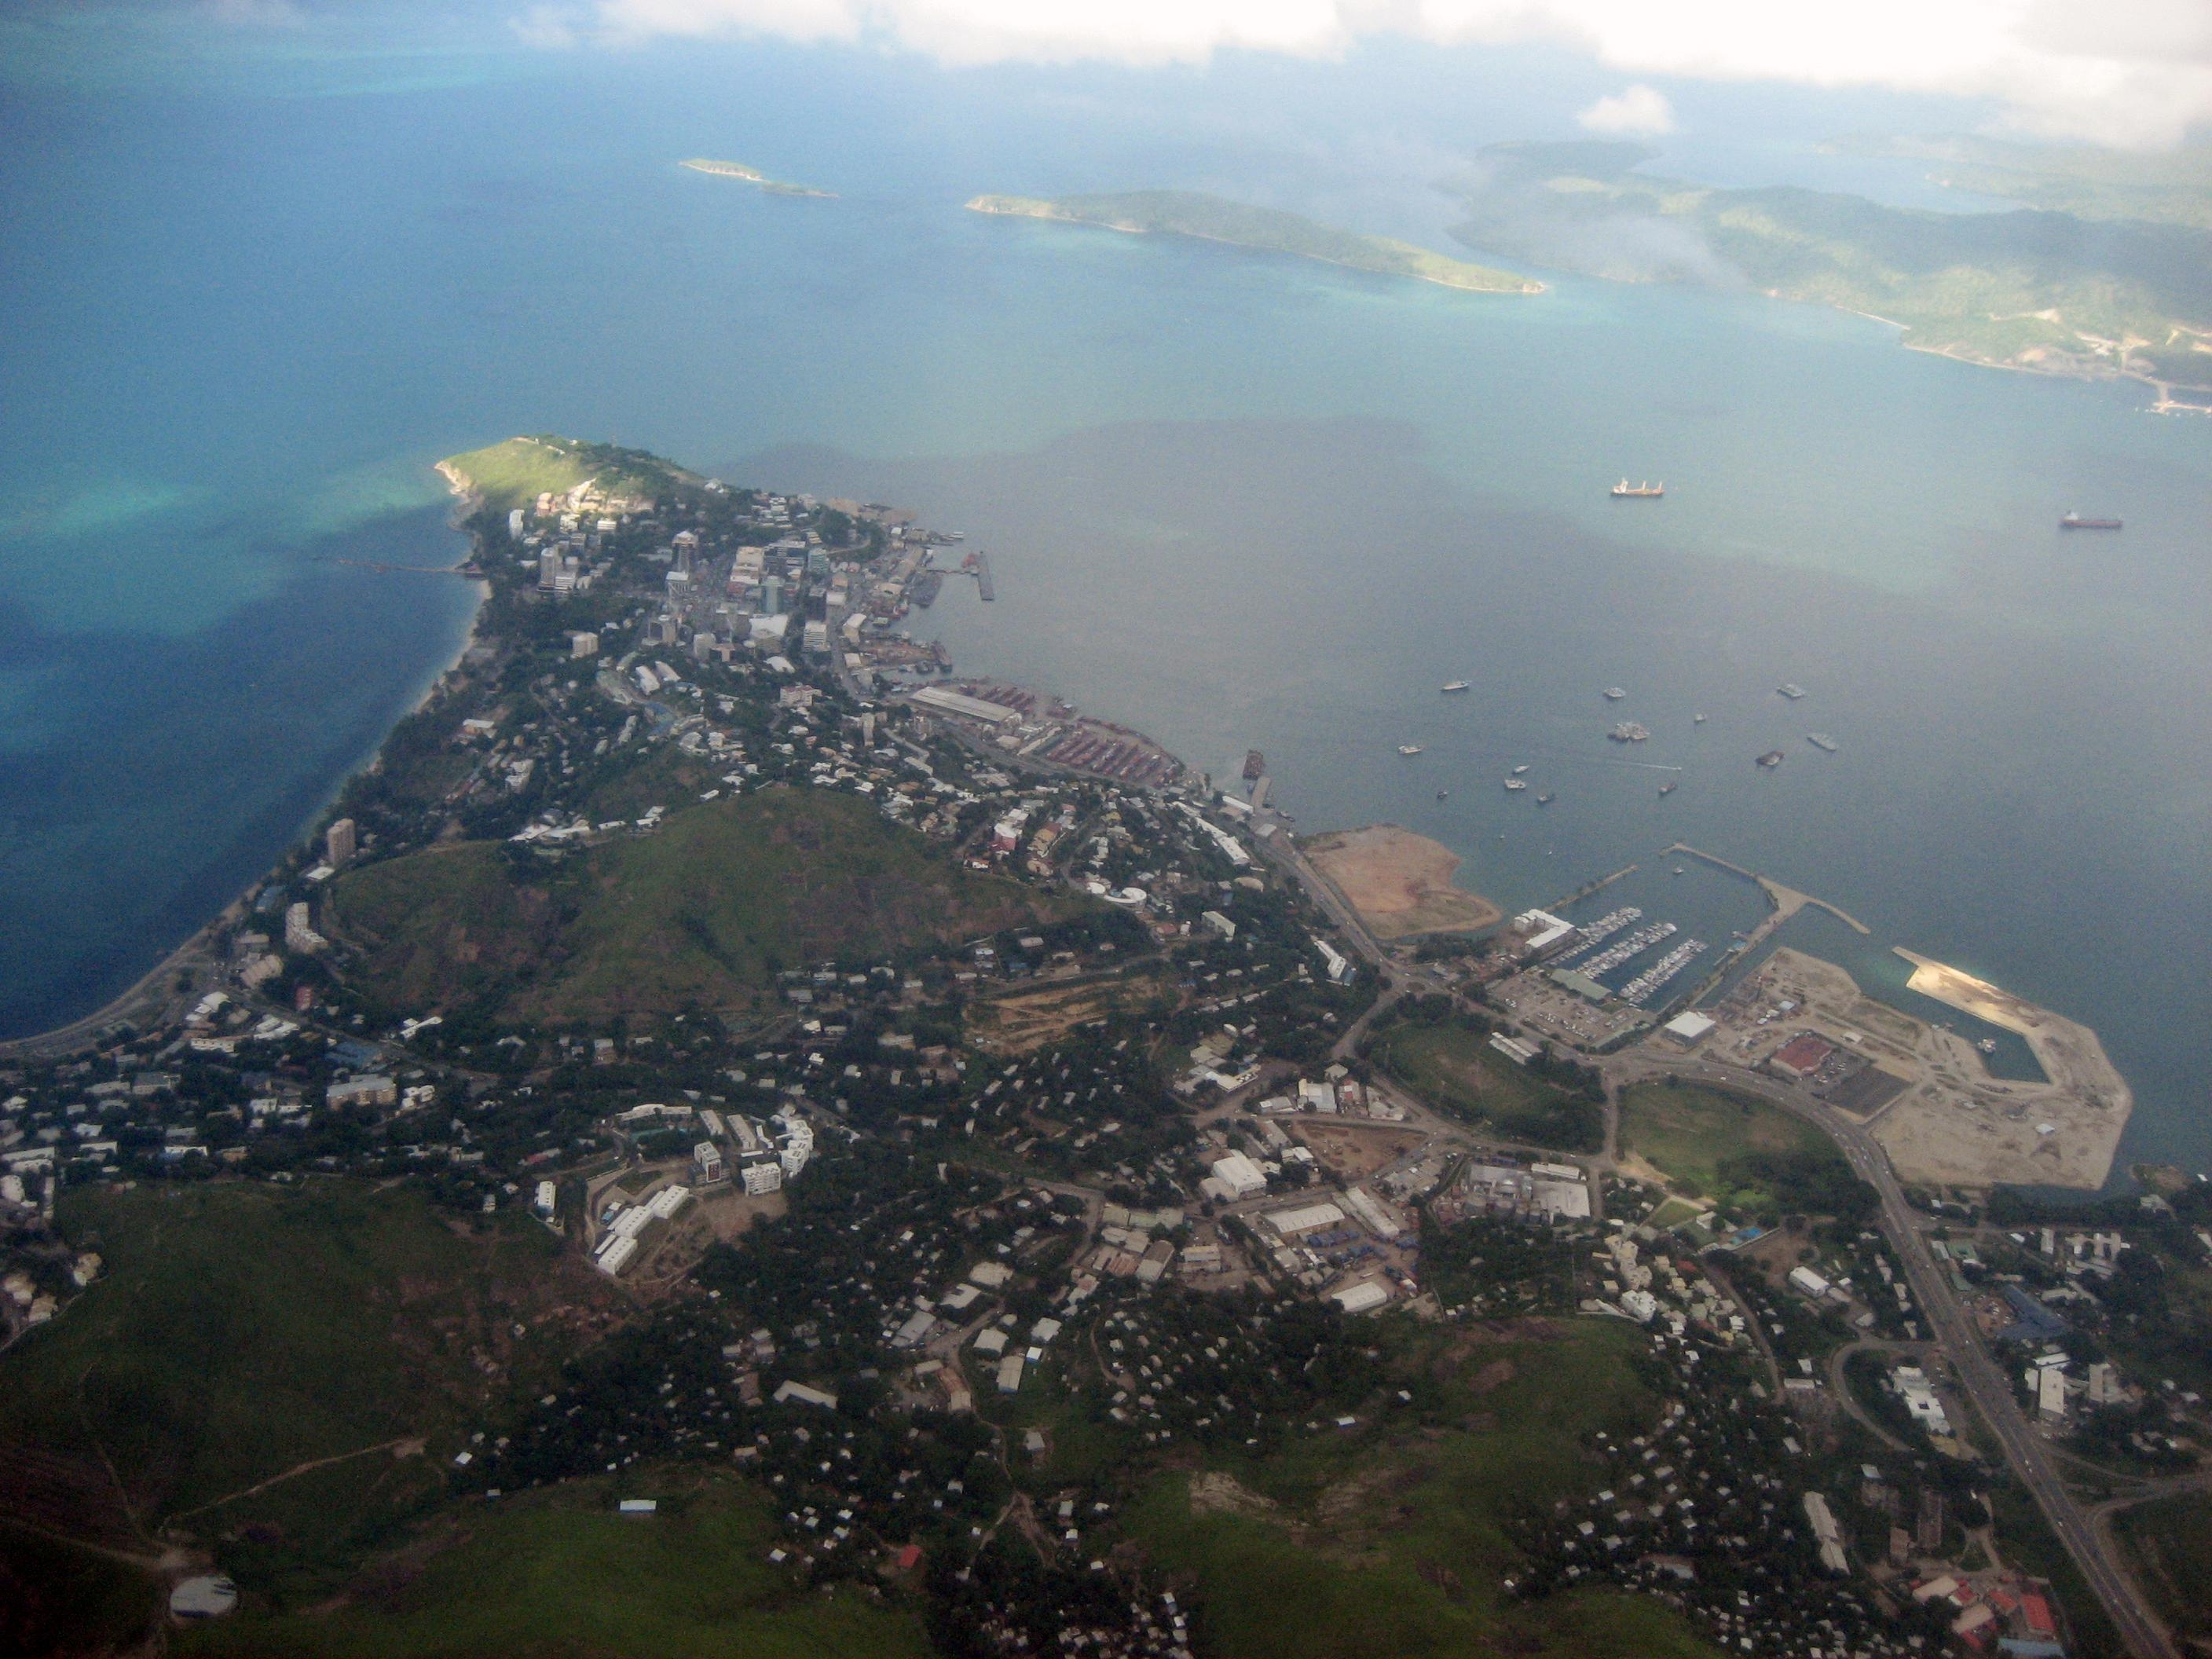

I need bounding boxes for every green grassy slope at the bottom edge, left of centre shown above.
[177,1471,929,1659]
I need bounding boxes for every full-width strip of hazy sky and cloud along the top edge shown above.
[13,0,2212,148]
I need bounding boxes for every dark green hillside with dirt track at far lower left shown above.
[0,1181,604,1619]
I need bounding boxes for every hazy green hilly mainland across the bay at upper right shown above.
[1453,144,2212,385]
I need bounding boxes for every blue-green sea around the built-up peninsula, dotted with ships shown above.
[0,42,2212,1163]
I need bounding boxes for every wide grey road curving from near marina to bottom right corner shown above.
[1599,1055,2179,1659]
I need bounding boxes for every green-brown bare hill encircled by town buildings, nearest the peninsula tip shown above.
[331,787,1064,1020]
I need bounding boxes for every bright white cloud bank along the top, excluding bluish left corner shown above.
[544,0,2212,146]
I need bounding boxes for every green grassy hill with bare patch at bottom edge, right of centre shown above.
[1128,1323,1712,1659]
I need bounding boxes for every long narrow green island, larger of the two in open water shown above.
[967,190,1544,295]
